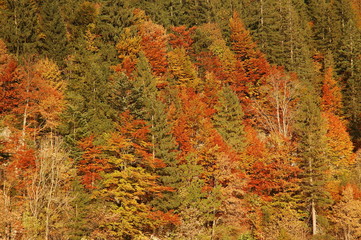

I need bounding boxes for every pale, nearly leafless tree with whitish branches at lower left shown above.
[23,138,75,239]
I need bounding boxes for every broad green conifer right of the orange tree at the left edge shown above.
[62,40,113,144]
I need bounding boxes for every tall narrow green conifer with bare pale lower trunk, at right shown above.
[295,83,330,235]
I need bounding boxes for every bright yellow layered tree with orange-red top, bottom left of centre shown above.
[96,112,170,239]
